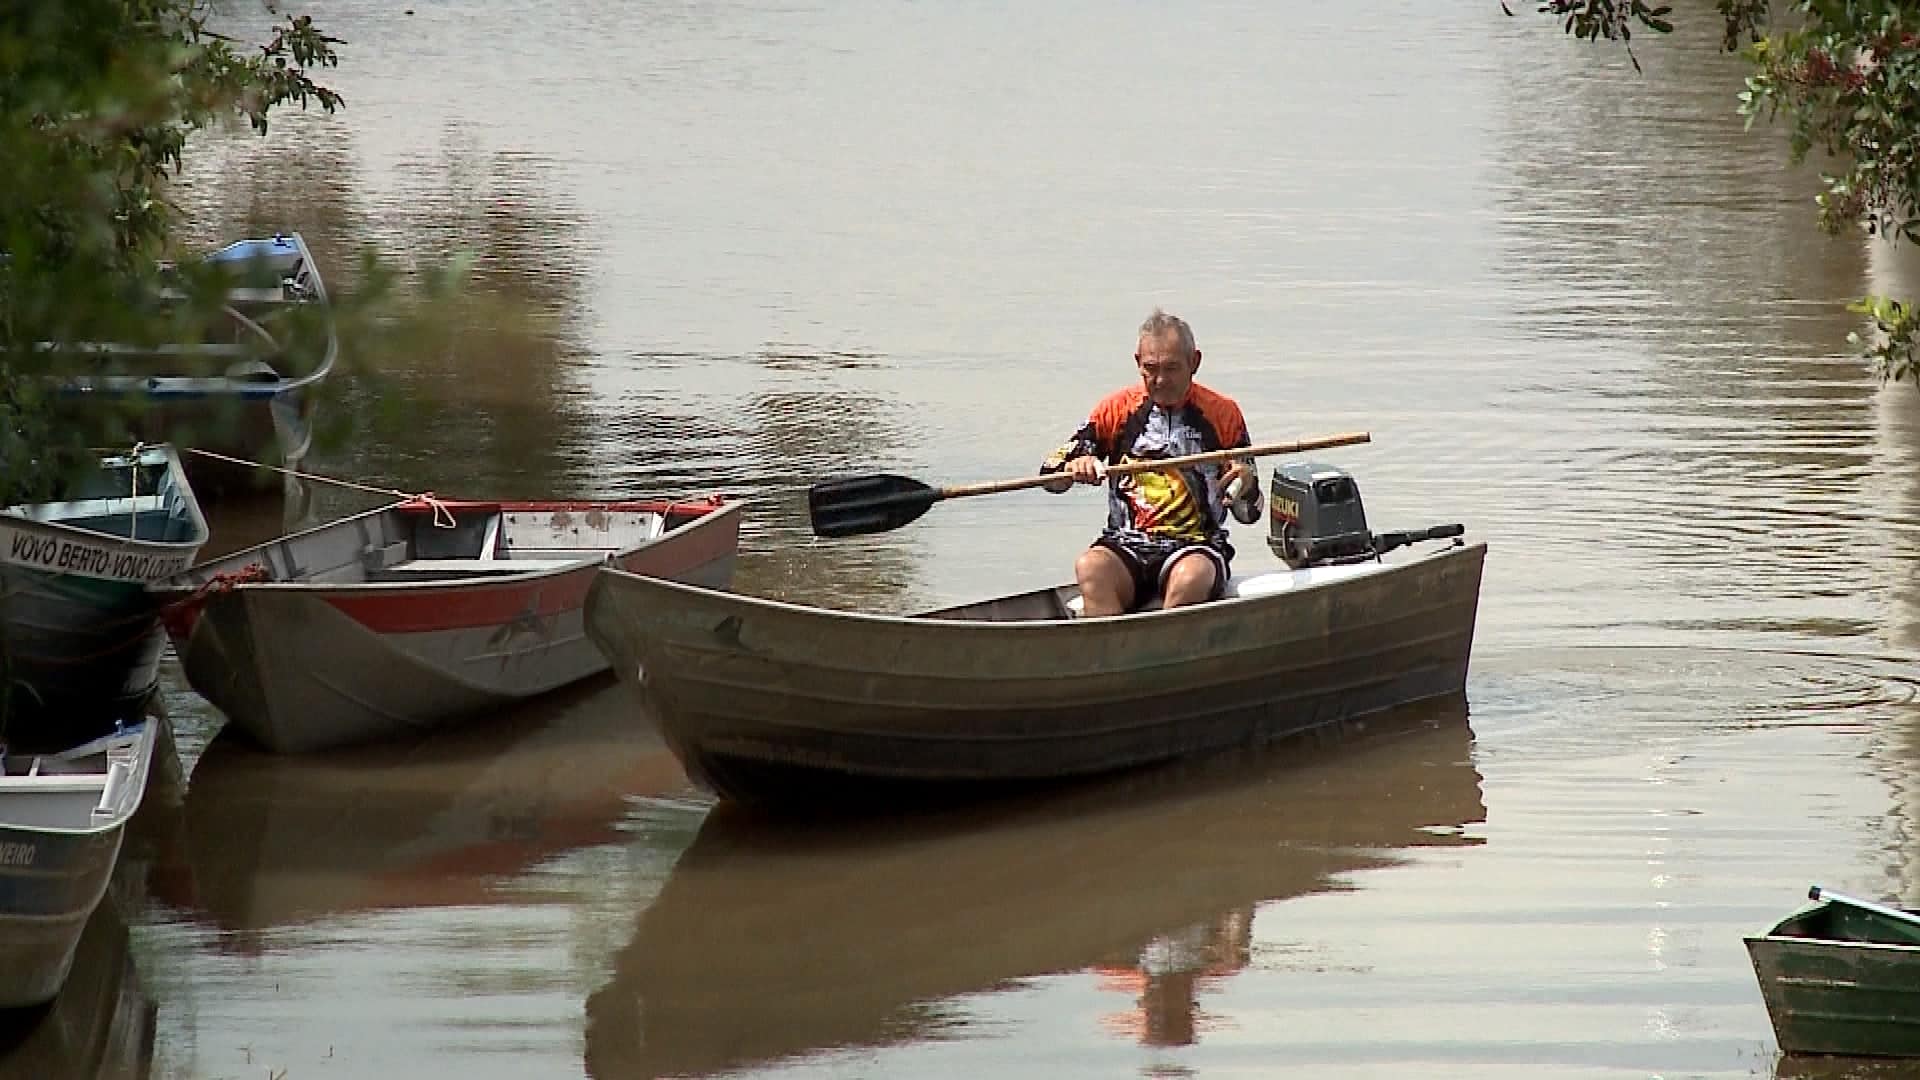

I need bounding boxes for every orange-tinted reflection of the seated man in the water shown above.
[1092,909,1254,1045]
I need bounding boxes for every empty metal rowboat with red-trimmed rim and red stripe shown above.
[156,498,743,753]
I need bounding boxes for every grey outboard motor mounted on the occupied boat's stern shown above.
[1267,461,1467,571]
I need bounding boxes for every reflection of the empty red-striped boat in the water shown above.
[157,676,687,933]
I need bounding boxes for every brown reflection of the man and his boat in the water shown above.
[586,701,1486,1080]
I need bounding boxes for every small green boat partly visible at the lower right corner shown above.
[1745,886,1920,1057]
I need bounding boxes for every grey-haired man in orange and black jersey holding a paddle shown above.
[1041,307,1263,615]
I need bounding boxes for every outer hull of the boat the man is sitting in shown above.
[588,544,1486,803]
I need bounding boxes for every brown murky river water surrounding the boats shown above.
[11,0,1920,1078]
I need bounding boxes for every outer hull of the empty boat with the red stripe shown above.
[177,505,739,753]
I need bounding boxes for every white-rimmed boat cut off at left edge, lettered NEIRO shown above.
[0,719,161,1009]
